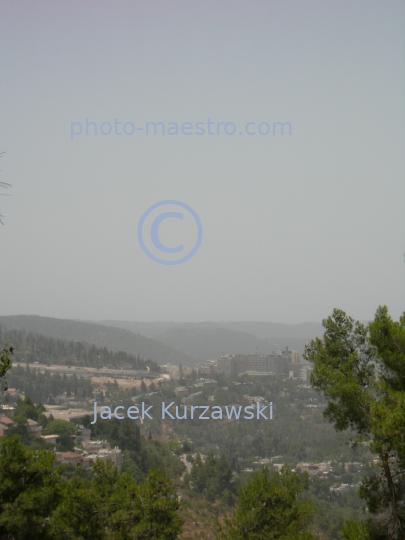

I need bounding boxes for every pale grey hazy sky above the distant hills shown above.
[0,0,405,323]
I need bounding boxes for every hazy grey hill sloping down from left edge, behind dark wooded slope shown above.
[0,315,195,366]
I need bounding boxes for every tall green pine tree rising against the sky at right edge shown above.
[305,307,405,540]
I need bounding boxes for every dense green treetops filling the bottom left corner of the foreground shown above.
[0,435,182,540]
